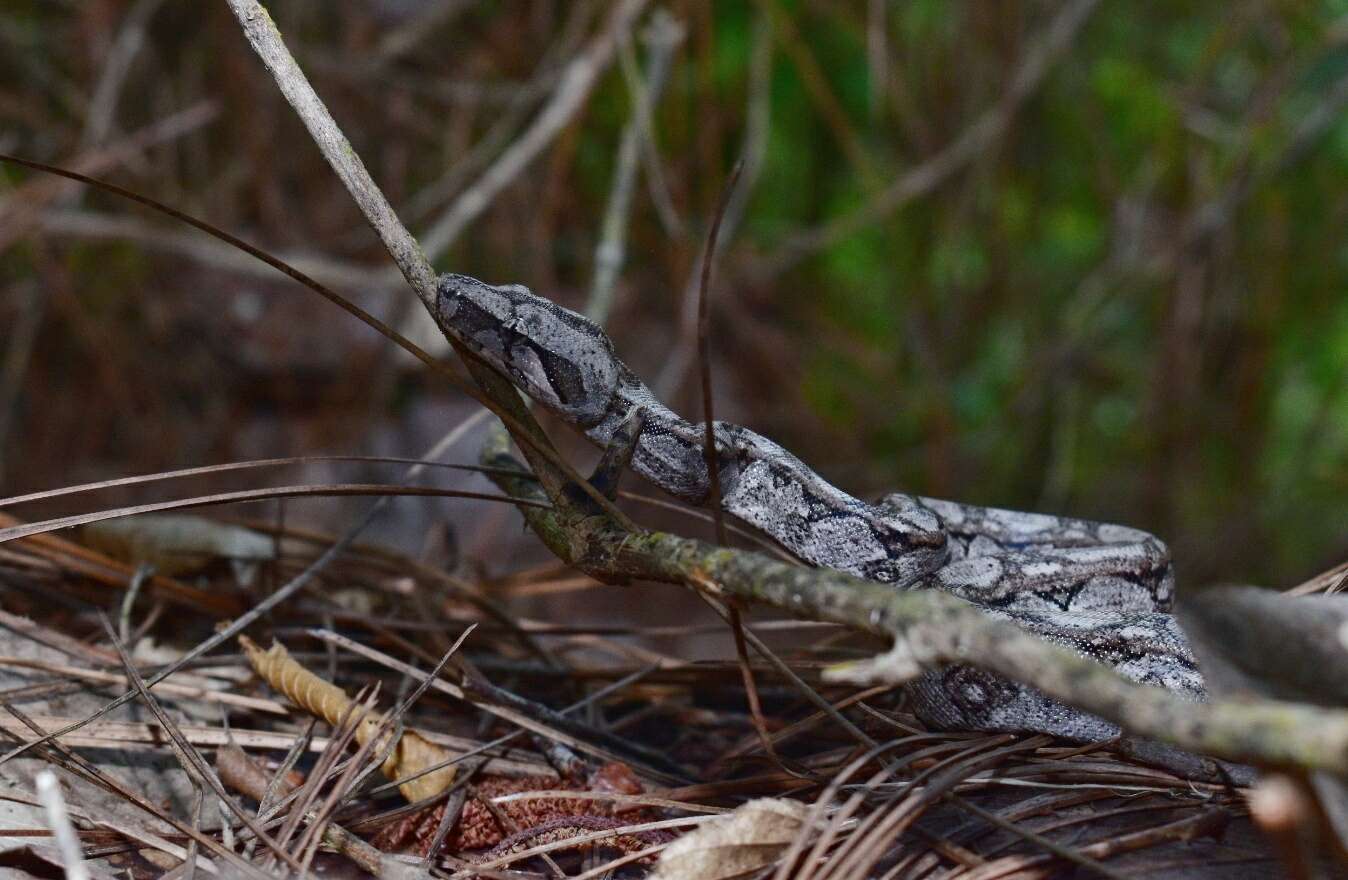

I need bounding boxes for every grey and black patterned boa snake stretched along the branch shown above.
[434,275,1204,741]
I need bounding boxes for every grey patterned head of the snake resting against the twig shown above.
[435,275,620,427]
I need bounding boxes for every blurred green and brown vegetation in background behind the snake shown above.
[0,0,1348,585]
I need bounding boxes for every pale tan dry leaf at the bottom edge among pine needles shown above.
[651,798,810,880]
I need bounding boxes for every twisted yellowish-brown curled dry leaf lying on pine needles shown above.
[239,636,454,803]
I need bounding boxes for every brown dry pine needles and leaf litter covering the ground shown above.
[0,501,1294,880]
